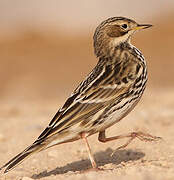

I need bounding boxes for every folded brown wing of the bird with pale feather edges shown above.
[34,61,139,141]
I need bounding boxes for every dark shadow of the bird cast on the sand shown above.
[32,148,145,179]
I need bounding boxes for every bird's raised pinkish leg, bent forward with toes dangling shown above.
[98,131,161,153]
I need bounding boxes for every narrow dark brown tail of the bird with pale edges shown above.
[0,143,46,173]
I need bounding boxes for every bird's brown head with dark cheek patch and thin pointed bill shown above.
[93,17,152,57]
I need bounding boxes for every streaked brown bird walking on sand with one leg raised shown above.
[1,17,159,173]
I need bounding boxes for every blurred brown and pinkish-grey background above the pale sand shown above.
[0,0,174,103]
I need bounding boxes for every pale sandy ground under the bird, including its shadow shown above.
[0,89,174,180]
